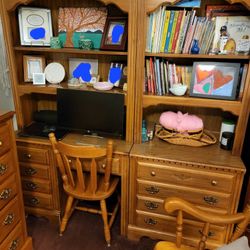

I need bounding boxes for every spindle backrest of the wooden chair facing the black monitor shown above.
[49,133,113,195]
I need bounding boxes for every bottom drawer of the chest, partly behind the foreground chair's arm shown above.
[136,211,226,242]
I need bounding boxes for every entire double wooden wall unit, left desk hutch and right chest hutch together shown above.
[0,0,250,246]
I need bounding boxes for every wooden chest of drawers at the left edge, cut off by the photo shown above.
[0,112,32,250]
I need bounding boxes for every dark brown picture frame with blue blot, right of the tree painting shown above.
[101,17,128,51]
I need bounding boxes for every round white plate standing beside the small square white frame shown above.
[44,62,65,84]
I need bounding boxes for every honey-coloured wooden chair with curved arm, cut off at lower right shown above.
[154,197,250,250]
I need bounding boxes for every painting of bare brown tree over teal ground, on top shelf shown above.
[58,7,107,49]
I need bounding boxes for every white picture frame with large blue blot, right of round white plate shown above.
[69,58,98,82]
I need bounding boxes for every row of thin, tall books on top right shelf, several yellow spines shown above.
[146,6,215,54]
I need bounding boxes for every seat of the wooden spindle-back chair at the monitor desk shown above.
[63,174,119,200]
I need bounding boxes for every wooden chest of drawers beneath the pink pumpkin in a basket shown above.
[128,144,245,247]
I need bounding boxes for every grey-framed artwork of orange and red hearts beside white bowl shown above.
[190,62,240,100]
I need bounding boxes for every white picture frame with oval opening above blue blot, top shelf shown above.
[18,7,53,46]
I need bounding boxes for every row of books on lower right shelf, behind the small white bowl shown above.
[144,57,192,95]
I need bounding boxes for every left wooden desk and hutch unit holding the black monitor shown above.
[0,0,137,230]
